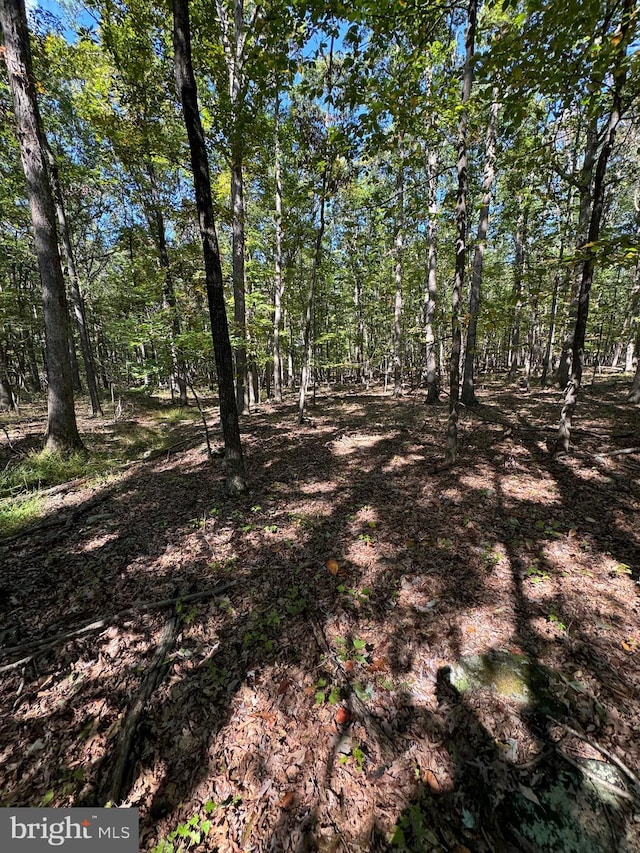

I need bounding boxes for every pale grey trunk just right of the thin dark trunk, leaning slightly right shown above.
[462,95,499,406]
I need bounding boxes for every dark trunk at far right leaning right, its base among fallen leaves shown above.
[556,0,633,453]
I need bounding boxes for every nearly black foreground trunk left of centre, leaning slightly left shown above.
[173,0,246,494]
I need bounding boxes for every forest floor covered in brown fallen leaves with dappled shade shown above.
[0,381,640,853]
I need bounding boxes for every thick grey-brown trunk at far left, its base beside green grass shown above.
[0,0,82,453]
